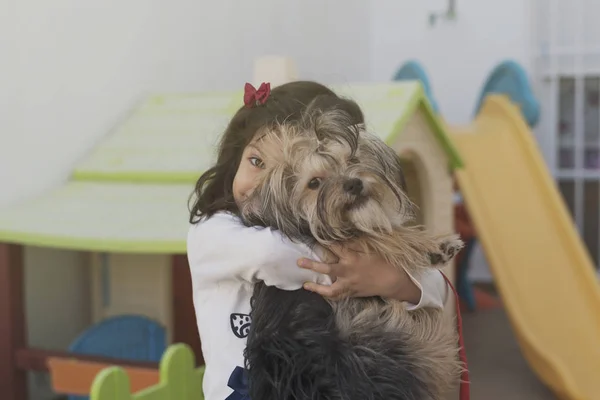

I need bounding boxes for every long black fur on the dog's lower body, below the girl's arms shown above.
[245,282,430,400]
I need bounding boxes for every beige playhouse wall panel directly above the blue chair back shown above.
[91,253,173,343]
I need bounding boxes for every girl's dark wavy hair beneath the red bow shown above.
[189,81,364,224]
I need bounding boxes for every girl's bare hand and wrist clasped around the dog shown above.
[298,245,421,304]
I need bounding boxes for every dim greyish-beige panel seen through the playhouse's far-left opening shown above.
[24,246,92,399]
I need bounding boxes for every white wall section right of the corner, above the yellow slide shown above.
[371,0,533,123]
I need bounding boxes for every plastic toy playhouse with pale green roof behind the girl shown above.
[0,82,461,400]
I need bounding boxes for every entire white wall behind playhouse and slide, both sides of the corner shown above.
[0,0,531,206]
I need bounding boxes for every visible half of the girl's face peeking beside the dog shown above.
[233,141,265,208]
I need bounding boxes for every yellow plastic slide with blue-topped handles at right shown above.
[448,95,600,400]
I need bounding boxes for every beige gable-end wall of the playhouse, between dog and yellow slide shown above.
[391,111,455,315]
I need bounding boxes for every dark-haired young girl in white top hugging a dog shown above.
[187,82,447,400]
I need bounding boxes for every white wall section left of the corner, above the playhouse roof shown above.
[0,0,369,206]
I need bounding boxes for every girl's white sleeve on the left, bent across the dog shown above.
[187,213,331,290]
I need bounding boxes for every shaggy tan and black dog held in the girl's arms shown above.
[241,104,462,400]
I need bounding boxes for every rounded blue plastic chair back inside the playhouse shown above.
[68,315,167,400]
